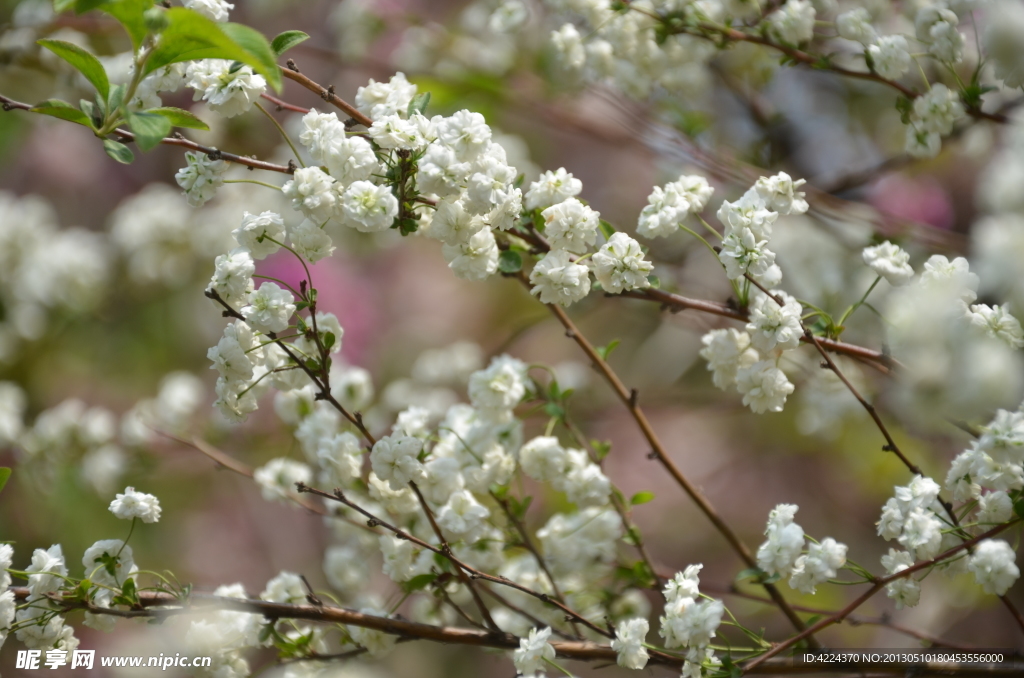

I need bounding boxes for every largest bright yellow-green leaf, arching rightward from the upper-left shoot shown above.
[143,7,282,91]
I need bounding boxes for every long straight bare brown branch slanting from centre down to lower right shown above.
[517,271,816,646]
